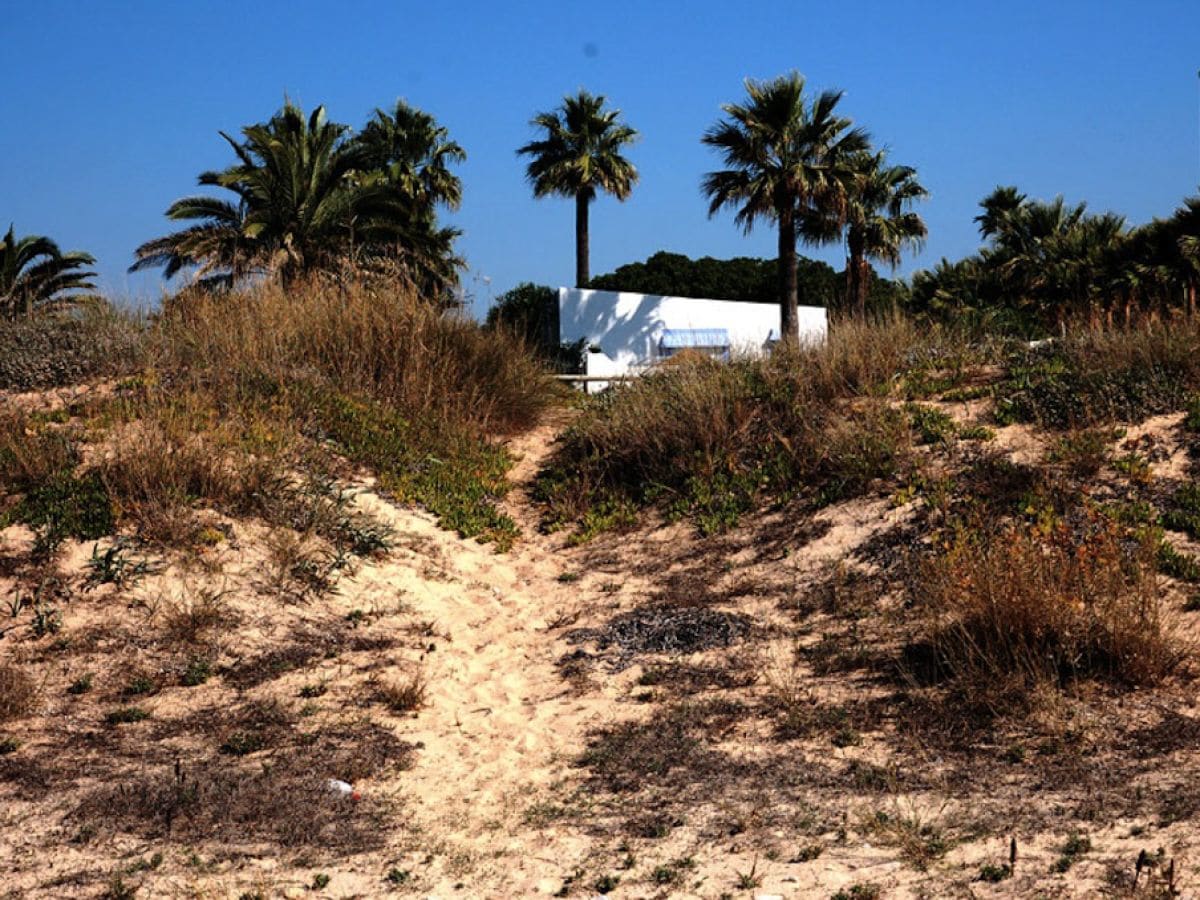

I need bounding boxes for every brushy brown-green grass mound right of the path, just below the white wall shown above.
[536,320,916,532]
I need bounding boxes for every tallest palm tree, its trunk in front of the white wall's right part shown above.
[702,72,868,342]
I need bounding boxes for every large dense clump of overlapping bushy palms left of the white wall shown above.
[131,101,466,298]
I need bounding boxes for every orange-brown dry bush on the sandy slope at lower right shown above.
[913,512,1177,712]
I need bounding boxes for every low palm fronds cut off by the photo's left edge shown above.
[0,224,96,318]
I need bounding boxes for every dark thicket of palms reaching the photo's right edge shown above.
[911,187,1200,330]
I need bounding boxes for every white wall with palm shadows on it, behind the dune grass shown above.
[558,288,826,374]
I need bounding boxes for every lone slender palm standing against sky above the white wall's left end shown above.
[517,90,637,287]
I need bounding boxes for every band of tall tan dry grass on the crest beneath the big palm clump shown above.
[156,281,552,436]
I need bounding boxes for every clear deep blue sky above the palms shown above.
[0,0,1200,308]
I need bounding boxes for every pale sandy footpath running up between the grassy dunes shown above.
[340,425,611,895]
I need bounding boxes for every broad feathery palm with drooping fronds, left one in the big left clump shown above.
[131,103,404,290]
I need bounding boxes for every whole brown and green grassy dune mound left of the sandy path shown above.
[0,281,556,547]
